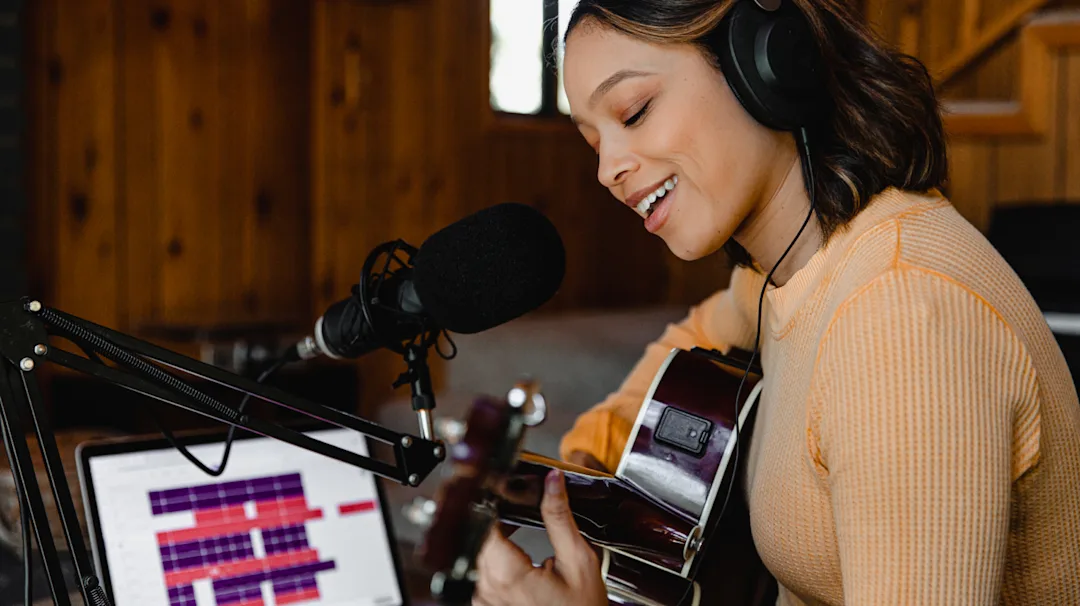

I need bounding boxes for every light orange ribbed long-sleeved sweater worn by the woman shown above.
[561,190,1080,606]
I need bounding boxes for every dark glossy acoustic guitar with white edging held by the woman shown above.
[418,349,775,606]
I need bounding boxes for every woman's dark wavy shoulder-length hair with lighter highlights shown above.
[563,0,948,267]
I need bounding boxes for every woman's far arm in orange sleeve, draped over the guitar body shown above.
[559,268,765,470]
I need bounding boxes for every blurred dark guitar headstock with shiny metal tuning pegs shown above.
[418,381,545,604]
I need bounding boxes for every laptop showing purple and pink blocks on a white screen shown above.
[77,428,407,606]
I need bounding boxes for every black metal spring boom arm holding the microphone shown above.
[0,298,446,606]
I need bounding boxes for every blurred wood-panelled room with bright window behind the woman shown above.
[0,0,1080,600]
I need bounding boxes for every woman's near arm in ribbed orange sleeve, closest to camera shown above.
[808,270,1038,606]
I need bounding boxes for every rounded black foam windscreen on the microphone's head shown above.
[413,203,566,334]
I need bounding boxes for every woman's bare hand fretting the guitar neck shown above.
[473,470,608,606]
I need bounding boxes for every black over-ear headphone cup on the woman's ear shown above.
[711,0,828,131]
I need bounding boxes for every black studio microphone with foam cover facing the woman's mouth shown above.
[287,203,566,360]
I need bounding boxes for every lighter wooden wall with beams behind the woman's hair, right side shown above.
[866,0,1080,229]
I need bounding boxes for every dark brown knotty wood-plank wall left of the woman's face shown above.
[27,0,727,341]
